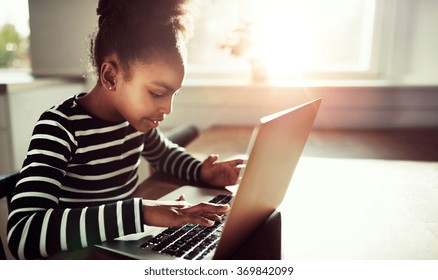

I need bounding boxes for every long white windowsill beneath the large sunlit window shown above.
[184,65,438,89]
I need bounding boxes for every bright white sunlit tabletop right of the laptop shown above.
[279,158,438,260]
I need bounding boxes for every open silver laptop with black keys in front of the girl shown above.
[96,98,321,260]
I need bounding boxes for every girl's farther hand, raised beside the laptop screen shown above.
[201,155,243,186]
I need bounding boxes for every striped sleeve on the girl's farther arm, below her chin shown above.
[142,129,202,182]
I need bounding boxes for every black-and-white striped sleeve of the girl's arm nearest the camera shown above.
[7,112,143,259]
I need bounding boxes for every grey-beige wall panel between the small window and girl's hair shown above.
[29,0,98,76]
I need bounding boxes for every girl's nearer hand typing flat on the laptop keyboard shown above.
[143,196,230,227]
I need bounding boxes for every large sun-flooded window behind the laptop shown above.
[189,0,377,80]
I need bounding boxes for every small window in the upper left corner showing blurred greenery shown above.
[0,0,30,69]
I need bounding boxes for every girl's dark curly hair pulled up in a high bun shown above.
[90,0,193,80]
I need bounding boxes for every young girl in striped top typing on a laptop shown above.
[8,0,242,259]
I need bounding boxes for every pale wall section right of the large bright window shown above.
[382,0,438,85]
